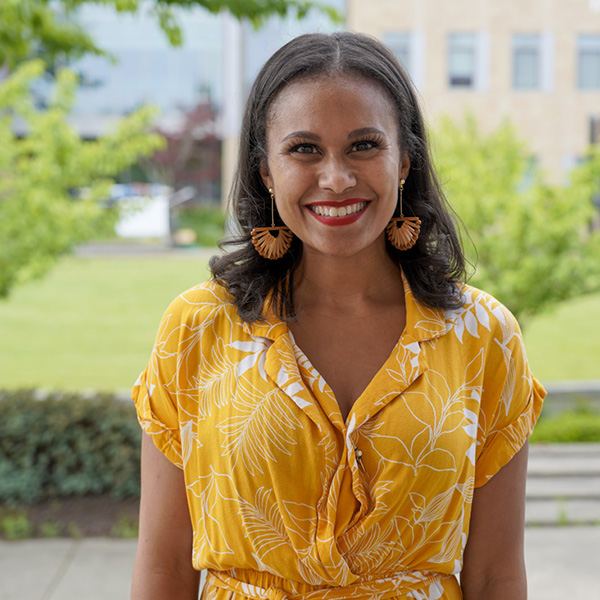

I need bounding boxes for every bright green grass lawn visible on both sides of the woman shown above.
[0,254,600,391]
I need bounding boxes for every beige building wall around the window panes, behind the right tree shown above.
[347,0,600,179]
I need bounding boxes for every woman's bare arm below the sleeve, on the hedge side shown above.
[132,434,199,599]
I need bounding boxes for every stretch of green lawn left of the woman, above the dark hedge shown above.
[0,255,208,391]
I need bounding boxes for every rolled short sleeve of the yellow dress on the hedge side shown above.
[132,300,182,468]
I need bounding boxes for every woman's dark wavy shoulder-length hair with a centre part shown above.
[210,32,465,322]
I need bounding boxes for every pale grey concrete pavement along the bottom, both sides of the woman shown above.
[0,526,600,600]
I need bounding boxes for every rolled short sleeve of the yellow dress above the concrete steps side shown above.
[475,309,546,487]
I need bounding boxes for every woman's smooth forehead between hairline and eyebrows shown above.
[267,75,399,138]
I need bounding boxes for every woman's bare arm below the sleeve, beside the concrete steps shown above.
[461,442,528,600]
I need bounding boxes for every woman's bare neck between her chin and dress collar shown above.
[294,239,404,313]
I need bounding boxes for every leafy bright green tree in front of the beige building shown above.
[434,116,600,321]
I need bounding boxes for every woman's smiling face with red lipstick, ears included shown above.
[261,75,410,257]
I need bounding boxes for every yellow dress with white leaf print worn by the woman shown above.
[134,274,545,600]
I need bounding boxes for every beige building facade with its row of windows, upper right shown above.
[347,0,600,180]
